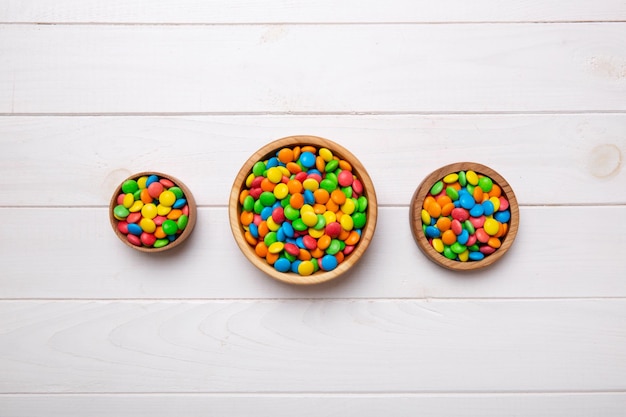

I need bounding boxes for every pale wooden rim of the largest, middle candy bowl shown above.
[228,135,378,285]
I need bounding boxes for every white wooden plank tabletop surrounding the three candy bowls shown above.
[0,0,626,417]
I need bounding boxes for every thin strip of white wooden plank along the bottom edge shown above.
[0,393,626,417]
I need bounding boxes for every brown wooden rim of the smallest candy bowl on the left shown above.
[109,172,197,253]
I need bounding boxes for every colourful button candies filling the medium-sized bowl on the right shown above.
[421,171,511,262]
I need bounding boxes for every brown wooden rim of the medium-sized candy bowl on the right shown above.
[409,162,519,271]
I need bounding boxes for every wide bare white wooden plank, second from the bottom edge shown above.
[0,299,626,394]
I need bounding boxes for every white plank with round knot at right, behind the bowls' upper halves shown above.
[0,114,626,206]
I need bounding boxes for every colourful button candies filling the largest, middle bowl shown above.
[239,146,368,275]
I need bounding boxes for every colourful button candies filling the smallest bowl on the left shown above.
[113,175,189,248]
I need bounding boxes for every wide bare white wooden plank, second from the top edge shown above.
[0,23,626,114]
